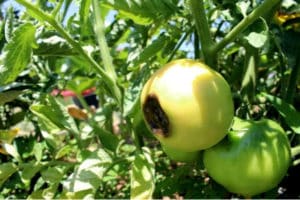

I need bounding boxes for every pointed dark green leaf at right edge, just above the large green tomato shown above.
[262,93,300,134]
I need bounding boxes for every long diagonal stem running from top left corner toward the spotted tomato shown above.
[16,0,121,103]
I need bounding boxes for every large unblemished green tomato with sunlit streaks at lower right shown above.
[203,119,291,197]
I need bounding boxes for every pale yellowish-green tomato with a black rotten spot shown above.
[141,59,233,152]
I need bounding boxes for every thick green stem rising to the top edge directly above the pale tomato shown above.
[189,0,216,67]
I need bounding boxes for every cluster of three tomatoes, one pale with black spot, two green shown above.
[141,59,291,196]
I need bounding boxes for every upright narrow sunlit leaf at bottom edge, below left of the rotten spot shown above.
[130,147,155,199]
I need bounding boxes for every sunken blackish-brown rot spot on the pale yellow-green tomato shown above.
[143,94,170,137]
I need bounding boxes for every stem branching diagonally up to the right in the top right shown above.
[212,0,280,54]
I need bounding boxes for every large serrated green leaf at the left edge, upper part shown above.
[0,23,36,85]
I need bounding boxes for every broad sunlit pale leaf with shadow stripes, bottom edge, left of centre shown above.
[63,149,112,198]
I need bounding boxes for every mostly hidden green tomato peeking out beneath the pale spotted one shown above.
[162,145,199,163]
